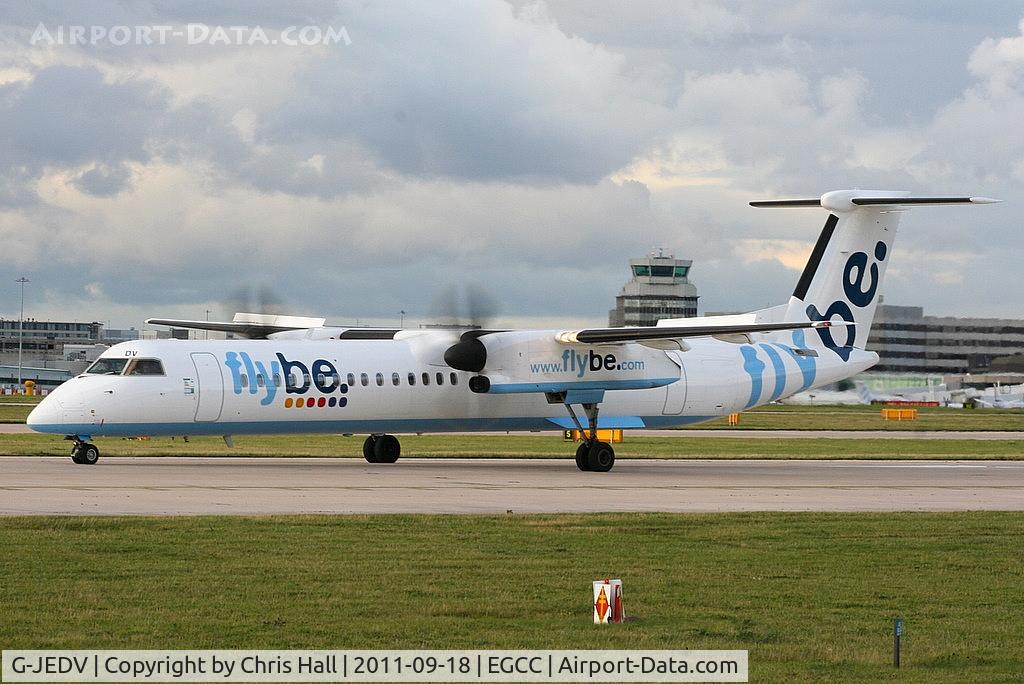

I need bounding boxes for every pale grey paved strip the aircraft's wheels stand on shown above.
[0,457,1024,515]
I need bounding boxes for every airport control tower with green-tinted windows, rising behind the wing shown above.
[608,249,697,328]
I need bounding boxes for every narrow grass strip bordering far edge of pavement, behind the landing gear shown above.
[6,431,1024,459]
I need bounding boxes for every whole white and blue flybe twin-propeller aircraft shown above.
[28,189,995,472]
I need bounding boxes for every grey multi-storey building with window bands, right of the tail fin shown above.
[867,304,1024,375]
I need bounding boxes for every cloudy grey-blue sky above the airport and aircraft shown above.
[0,0,1024,327]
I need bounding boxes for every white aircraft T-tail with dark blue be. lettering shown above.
[751,189,998,360]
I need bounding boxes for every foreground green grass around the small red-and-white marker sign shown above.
[0,513,1024,682]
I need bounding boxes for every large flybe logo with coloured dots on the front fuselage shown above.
[224,351,348,408]
